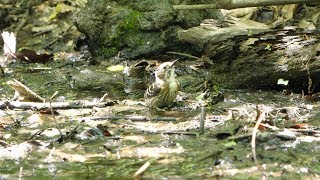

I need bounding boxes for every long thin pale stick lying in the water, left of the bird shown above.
[0,101,116,110]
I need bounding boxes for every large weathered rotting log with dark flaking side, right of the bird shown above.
[179,19,320,92]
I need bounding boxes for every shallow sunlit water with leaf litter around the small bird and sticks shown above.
[0,61,320,179]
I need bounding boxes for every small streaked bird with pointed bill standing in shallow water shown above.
[144,60,180,109]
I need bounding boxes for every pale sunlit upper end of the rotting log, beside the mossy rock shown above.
[178,18,273,57]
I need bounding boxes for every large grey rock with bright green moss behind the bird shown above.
[74,0,221,58]
